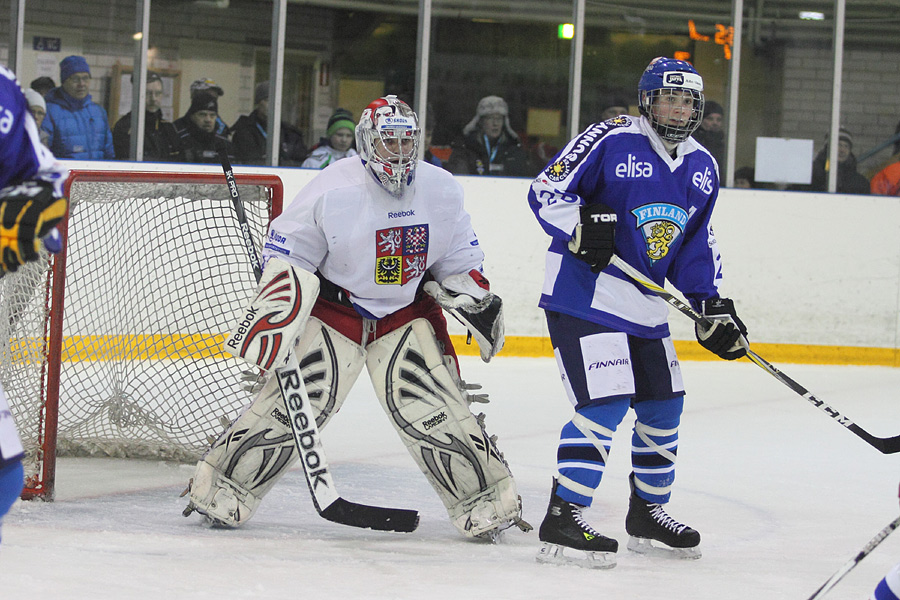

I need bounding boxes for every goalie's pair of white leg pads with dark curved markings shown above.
[188,318,521,536]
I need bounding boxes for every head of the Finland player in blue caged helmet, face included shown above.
[638,57,704,142]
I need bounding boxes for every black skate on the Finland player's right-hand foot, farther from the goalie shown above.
[625,473,700,559]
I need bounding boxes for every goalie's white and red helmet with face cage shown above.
[356,96,421,198]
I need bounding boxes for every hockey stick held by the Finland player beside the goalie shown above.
[610,255,900,454]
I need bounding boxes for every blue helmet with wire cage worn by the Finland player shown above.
[638,56,705,142]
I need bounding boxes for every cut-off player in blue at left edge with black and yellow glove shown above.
[0,66,67,544]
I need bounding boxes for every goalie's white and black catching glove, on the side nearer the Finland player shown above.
[423,269,504,362]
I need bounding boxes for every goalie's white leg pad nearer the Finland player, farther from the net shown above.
[366,319,523,537]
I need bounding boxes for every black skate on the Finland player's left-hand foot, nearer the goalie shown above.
[537,479,619,569]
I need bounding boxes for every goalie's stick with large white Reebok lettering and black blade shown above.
[218,146,419,532]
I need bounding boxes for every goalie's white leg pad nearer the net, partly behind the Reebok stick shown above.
[188,318,365,527]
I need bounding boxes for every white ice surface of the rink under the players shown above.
[0,357,900,600]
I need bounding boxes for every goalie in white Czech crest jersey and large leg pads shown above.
[185,96,530,538]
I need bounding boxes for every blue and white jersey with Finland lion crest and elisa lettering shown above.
[528,116,721,338]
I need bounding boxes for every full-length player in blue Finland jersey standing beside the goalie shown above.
[528,58,747,568]
